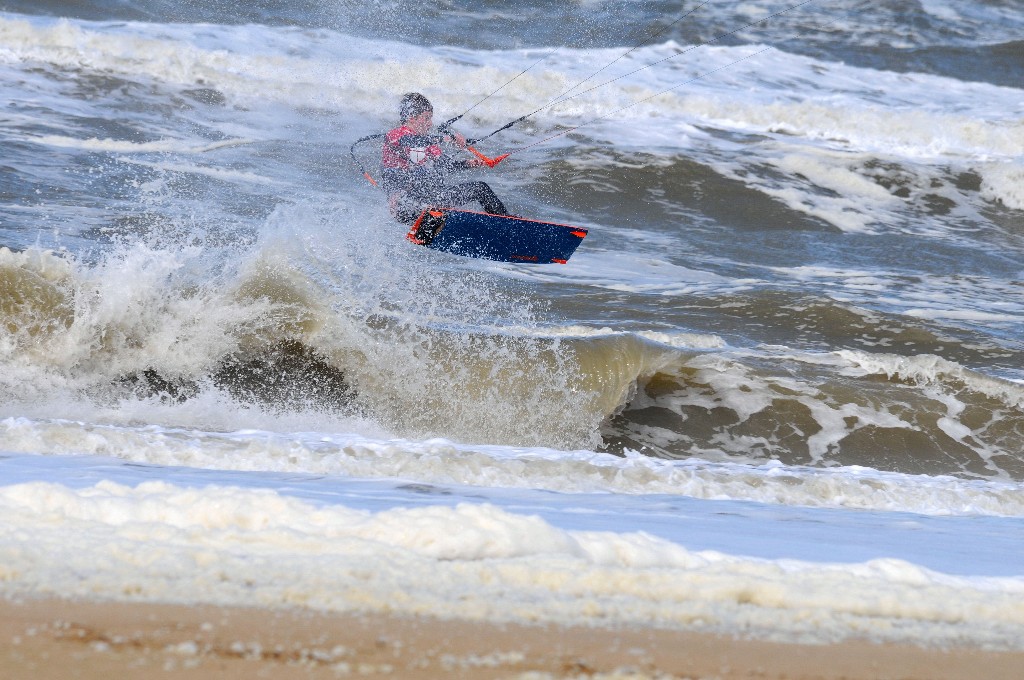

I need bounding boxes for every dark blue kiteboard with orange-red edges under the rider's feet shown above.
[406,208,587,264]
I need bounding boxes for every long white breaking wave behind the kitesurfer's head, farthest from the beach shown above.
[6,14,1024,160]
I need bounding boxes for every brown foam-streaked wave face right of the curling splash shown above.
[602,351,1024,479]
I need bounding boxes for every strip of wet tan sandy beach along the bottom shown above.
[0,599,1024,680]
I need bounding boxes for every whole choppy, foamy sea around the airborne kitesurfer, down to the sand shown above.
[0,0,1024,646]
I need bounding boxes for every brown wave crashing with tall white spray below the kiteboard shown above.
[0,237,606,447]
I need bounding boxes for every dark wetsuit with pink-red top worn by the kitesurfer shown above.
[381,125,507,224]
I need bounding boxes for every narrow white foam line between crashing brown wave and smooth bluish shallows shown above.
[0,418,1024,516]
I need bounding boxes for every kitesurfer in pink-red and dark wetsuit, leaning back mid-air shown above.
[381,92,508,224]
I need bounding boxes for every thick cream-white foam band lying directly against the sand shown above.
[0,482,1024,649]
